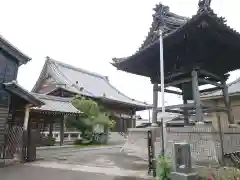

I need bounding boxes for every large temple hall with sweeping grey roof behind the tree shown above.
[32,57,151,132]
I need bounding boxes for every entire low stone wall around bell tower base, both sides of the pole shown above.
[123,124,240,165]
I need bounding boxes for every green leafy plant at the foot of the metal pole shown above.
[157,156,171,180]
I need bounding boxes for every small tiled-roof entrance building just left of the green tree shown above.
[29,93,82,146]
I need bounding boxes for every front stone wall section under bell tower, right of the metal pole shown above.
[163,125,221,164]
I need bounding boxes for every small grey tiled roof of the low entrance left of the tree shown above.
[32,93,81,114]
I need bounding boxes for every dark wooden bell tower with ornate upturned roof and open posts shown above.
[112,0,240,124]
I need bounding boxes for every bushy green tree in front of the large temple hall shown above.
[67,96,115,140]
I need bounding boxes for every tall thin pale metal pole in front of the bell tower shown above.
[159,29,165,156]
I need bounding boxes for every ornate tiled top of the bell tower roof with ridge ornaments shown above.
[111,0,236,70]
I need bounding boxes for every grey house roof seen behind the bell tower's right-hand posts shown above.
[201,78,240,99]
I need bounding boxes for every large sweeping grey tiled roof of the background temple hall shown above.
[33,58,150,108]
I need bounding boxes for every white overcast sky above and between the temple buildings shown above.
[0,0,240,118]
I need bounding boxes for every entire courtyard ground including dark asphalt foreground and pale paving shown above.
[0,147,151,180]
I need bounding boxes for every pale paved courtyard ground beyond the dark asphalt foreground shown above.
[28,147,151,180]
